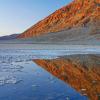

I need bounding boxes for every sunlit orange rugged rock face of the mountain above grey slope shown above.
[18,0,100,38]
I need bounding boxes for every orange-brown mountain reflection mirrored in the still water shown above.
[34,55,100,100]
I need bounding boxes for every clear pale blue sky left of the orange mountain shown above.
[0,0,72,36]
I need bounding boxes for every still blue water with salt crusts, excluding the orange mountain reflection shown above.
[0,49,88,100]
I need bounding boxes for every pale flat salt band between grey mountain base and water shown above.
[0,44,100,54]
